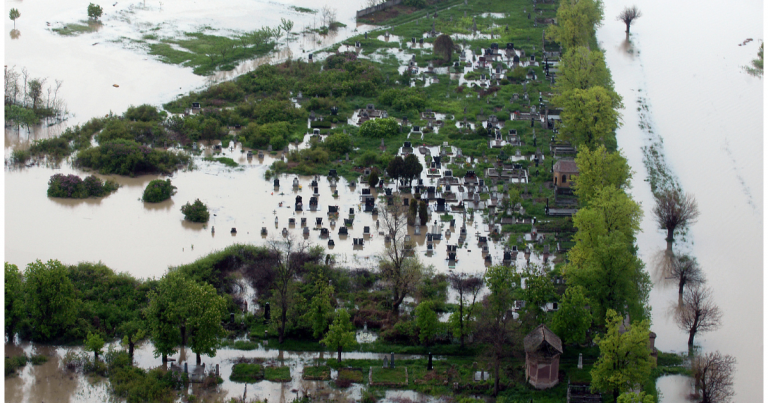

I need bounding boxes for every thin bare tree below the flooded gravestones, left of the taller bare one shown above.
[267,235,309,344]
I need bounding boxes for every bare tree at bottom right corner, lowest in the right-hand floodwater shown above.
[691,351,736,403]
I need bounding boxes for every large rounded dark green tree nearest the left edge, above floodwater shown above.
[23,259,78,341]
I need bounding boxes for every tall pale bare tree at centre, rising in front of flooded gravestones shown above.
[379,196,424,315]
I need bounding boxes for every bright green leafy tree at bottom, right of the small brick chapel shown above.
[590,309,653,403]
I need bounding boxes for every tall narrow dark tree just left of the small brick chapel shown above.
[476,266,520,395]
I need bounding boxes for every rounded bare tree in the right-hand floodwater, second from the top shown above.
[653,189,699,242]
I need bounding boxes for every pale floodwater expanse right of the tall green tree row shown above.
[598,0,764,402]
